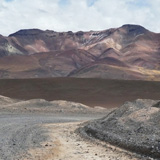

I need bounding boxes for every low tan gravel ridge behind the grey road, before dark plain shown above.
[0,96,108,114]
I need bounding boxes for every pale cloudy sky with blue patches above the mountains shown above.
[0,0,160,36]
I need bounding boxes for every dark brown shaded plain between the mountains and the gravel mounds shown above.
[0,78,160,108]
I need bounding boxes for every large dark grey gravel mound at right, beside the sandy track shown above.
[80,99,160,158]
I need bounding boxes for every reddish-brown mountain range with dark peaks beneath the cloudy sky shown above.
[0,25,160,80]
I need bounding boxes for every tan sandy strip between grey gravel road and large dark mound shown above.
[25,122,151,160]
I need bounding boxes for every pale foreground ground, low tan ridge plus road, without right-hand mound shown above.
[0,96,156,160]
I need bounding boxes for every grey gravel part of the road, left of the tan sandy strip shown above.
[0,114,99,160]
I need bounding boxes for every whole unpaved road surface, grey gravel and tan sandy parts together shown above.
[0,112,151,160]
